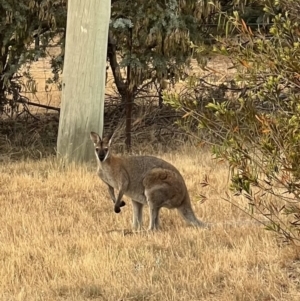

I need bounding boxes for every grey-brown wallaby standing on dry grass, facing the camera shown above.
[90,132,205,230]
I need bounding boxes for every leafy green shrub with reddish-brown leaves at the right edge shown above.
[165,0,300,243]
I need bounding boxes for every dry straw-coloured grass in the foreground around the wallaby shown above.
[0,150,300,301]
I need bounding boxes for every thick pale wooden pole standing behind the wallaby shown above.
[57,0,111,163]
